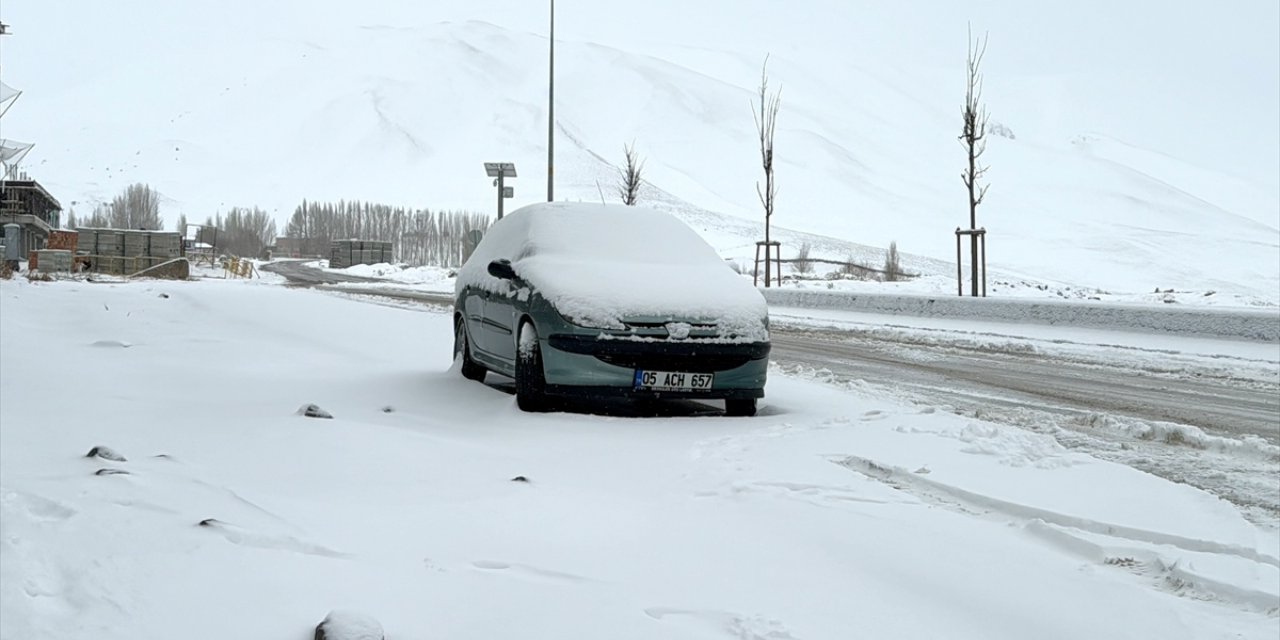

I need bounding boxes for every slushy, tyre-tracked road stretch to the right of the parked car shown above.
[773,308,1280,527]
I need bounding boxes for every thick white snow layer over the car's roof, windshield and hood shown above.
[457,202,768,342]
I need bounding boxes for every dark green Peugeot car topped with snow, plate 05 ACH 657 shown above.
[453,202,769,416]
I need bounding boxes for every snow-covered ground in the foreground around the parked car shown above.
[0,279,1280,640]
